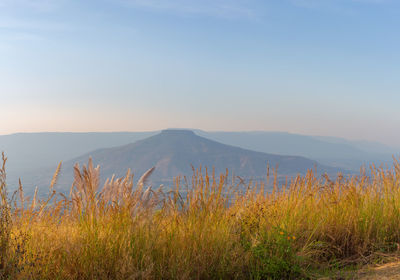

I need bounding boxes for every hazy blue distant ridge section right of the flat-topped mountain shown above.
[196,131,400,172]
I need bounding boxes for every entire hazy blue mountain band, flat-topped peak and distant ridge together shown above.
[0,130,396,194]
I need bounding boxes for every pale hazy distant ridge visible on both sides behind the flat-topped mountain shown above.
[0,130,392,192]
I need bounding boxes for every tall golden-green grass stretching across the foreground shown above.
[0,152,400,279]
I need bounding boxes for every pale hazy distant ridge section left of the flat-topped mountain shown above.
[0,132,157,190]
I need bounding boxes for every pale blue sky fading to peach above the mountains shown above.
[0,0,400,147]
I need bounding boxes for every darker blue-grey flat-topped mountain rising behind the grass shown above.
[47,130,337,192]
